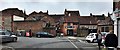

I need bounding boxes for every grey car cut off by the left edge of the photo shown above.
[0,29,17,42]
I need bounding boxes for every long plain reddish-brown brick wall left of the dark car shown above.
[14,21,45,33]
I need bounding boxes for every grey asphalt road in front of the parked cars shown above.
[2,37,98,50]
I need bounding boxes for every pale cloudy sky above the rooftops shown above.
[0,0,113,16]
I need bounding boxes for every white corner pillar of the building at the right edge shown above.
[112,9,120,48]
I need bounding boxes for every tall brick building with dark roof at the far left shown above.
[1,8,25,31]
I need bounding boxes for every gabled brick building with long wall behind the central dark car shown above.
[14,11,56,35]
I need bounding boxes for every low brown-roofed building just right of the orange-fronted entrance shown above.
[78,16,97,36]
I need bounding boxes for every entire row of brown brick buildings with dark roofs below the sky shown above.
[2,8,113,36]
